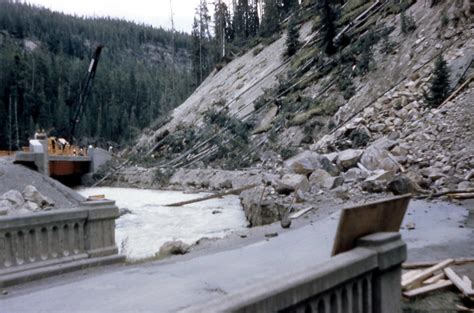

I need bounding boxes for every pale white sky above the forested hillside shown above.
[25,0,208,33]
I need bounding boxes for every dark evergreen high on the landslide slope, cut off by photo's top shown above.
[317,0,337,55]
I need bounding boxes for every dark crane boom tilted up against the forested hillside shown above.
[68,45,103,143]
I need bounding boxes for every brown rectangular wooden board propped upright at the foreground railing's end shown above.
[332,194,411,256]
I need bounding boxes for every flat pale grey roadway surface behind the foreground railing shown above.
[0,201,473,313]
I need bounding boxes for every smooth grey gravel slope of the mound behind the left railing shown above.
[0,158,85,209]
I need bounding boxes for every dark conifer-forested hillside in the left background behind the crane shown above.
[0,1,193,150]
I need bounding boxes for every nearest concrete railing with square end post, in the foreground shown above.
[186,233,406,313]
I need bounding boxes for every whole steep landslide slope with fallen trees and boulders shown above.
[113,1,474,225]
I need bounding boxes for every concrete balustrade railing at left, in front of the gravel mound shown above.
[0,200,124,287]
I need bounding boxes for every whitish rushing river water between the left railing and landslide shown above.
[77,187,247,261]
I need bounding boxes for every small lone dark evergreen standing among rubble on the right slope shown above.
[426,54,449,107]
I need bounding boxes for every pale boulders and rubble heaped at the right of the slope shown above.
[311,66,474,194]
